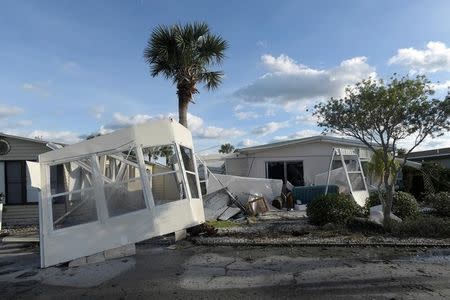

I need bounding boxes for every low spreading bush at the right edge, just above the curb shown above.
[392,216,450,238]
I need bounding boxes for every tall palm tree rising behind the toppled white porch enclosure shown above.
[144,23,228,127]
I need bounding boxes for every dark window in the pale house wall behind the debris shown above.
[266,161,305,186]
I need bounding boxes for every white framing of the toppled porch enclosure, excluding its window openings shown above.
[39,120,205,267]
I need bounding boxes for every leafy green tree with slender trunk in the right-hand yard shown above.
[314,74,450,228]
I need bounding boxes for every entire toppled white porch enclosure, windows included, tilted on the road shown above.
[39,120,205,267]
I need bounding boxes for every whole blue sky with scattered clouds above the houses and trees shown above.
[0,0,450,151]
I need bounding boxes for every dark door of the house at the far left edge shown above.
[5,161,27,205]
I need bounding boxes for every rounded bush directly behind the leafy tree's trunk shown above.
[365,192,419,219]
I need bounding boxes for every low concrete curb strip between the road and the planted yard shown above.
[192,237,450,248]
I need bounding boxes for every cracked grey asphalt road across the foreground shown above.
[0,242,450,299]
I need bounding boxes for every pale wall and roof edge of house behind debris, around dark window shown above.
[226,142,366,185]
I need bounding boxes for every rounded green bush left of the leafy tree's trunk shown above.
[306,194,359,226]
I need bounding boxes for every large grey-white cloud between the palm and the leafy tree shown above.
[234,54,376,110]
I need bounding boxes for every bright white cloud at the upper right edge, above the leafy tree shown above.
[388,42,450,73]
